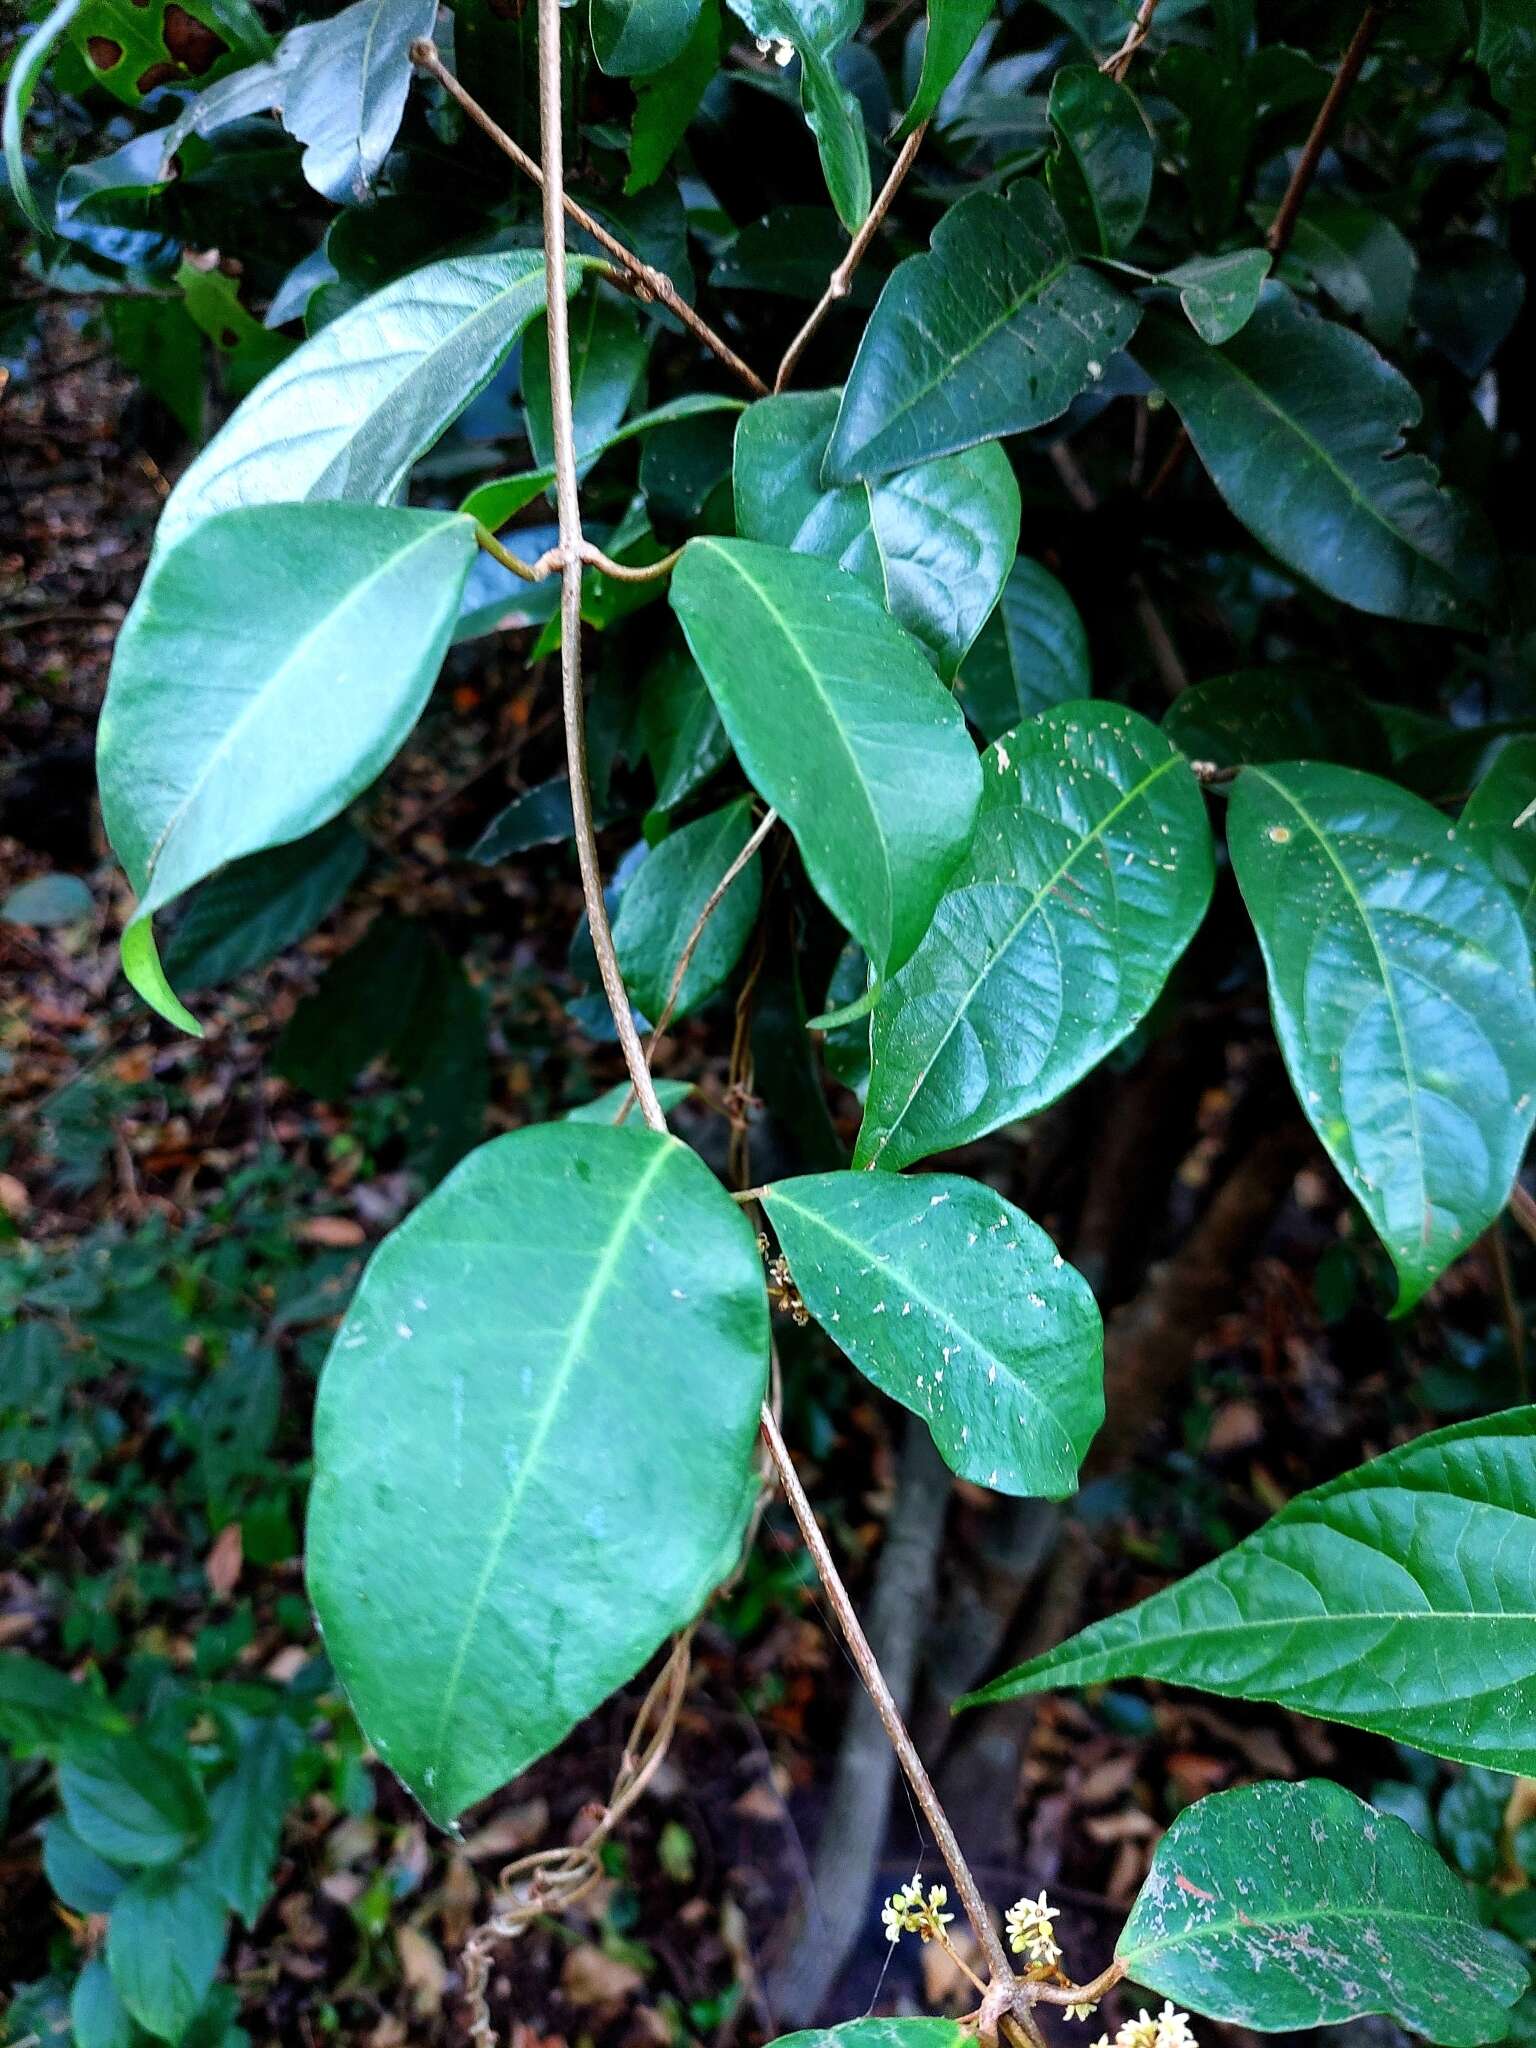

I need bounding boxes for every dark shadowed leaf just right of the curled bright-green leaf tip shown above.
[166,817,369,993]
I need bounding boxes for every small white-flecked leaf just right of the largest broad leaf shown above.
[762,1174,1104,1501]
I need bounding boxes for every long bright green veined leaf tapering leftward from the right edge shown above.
[965,1407,1536,1772]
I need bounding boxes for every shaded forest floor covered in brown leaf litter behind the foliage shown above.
[0,307,1503,2048]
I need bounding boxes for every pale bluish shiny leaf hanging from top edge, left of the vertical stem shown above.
[283,0,436,207]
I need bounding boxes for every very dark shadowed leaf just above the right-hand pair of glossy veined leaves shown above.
[1163,668,1389,770]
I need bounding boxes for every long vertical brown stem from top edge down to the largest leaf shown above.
[539,0,668,1130]
